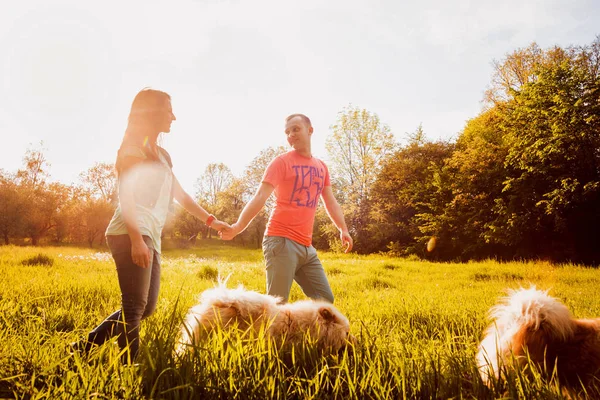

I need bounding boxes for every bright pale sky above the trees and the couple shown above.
[0,0,600,194]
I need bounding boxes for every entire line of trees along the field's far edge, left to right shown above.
[0,36,600,264]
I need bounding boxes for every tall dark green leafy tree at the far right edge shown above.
[497,47,600,263]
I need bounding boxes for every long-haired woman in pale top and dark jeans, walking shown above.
[72,89,229,362]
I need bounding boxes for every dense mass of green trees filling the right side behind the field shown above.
[369,37,600,264]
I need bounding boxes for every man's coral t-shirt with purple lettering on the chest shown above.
[262,150,331,246]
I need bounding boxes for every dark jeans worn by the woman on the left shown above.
[87,235,160,362]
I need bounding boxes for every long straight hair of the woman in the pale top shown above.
[115,88,171,176]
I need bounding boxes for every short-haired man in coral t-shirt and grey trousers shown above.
[221,114,352,303]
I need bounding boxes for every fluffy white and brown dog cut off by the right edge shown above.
[477,287,600,389]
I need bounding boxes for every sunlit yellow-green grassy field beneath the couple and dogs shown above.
[0,245,600,399]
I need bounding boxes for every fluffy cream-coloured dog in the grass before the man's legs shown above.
[177,282,355,354]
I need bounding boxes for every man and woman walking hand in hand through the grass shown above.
[71,89,352,362]
